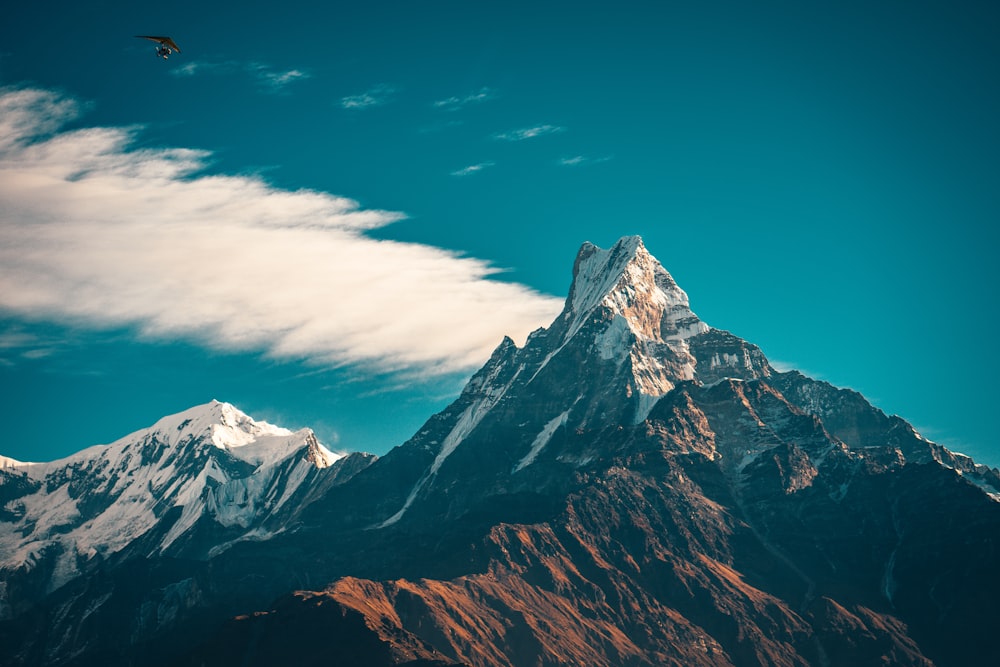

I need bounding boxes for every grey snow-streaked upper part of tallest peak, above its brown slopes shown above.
[358,237,1000,528]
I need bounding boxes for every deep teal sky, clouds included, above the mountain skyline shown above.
[0,1,1000,465]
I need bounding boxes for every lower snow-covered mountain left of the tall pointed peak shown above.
[0,401,343,596]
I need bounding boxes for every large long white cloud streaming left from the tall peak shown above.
[0,88,561,373]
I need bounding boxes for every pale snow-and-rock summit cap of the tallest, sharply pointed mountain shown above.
[562,236,709,343]
